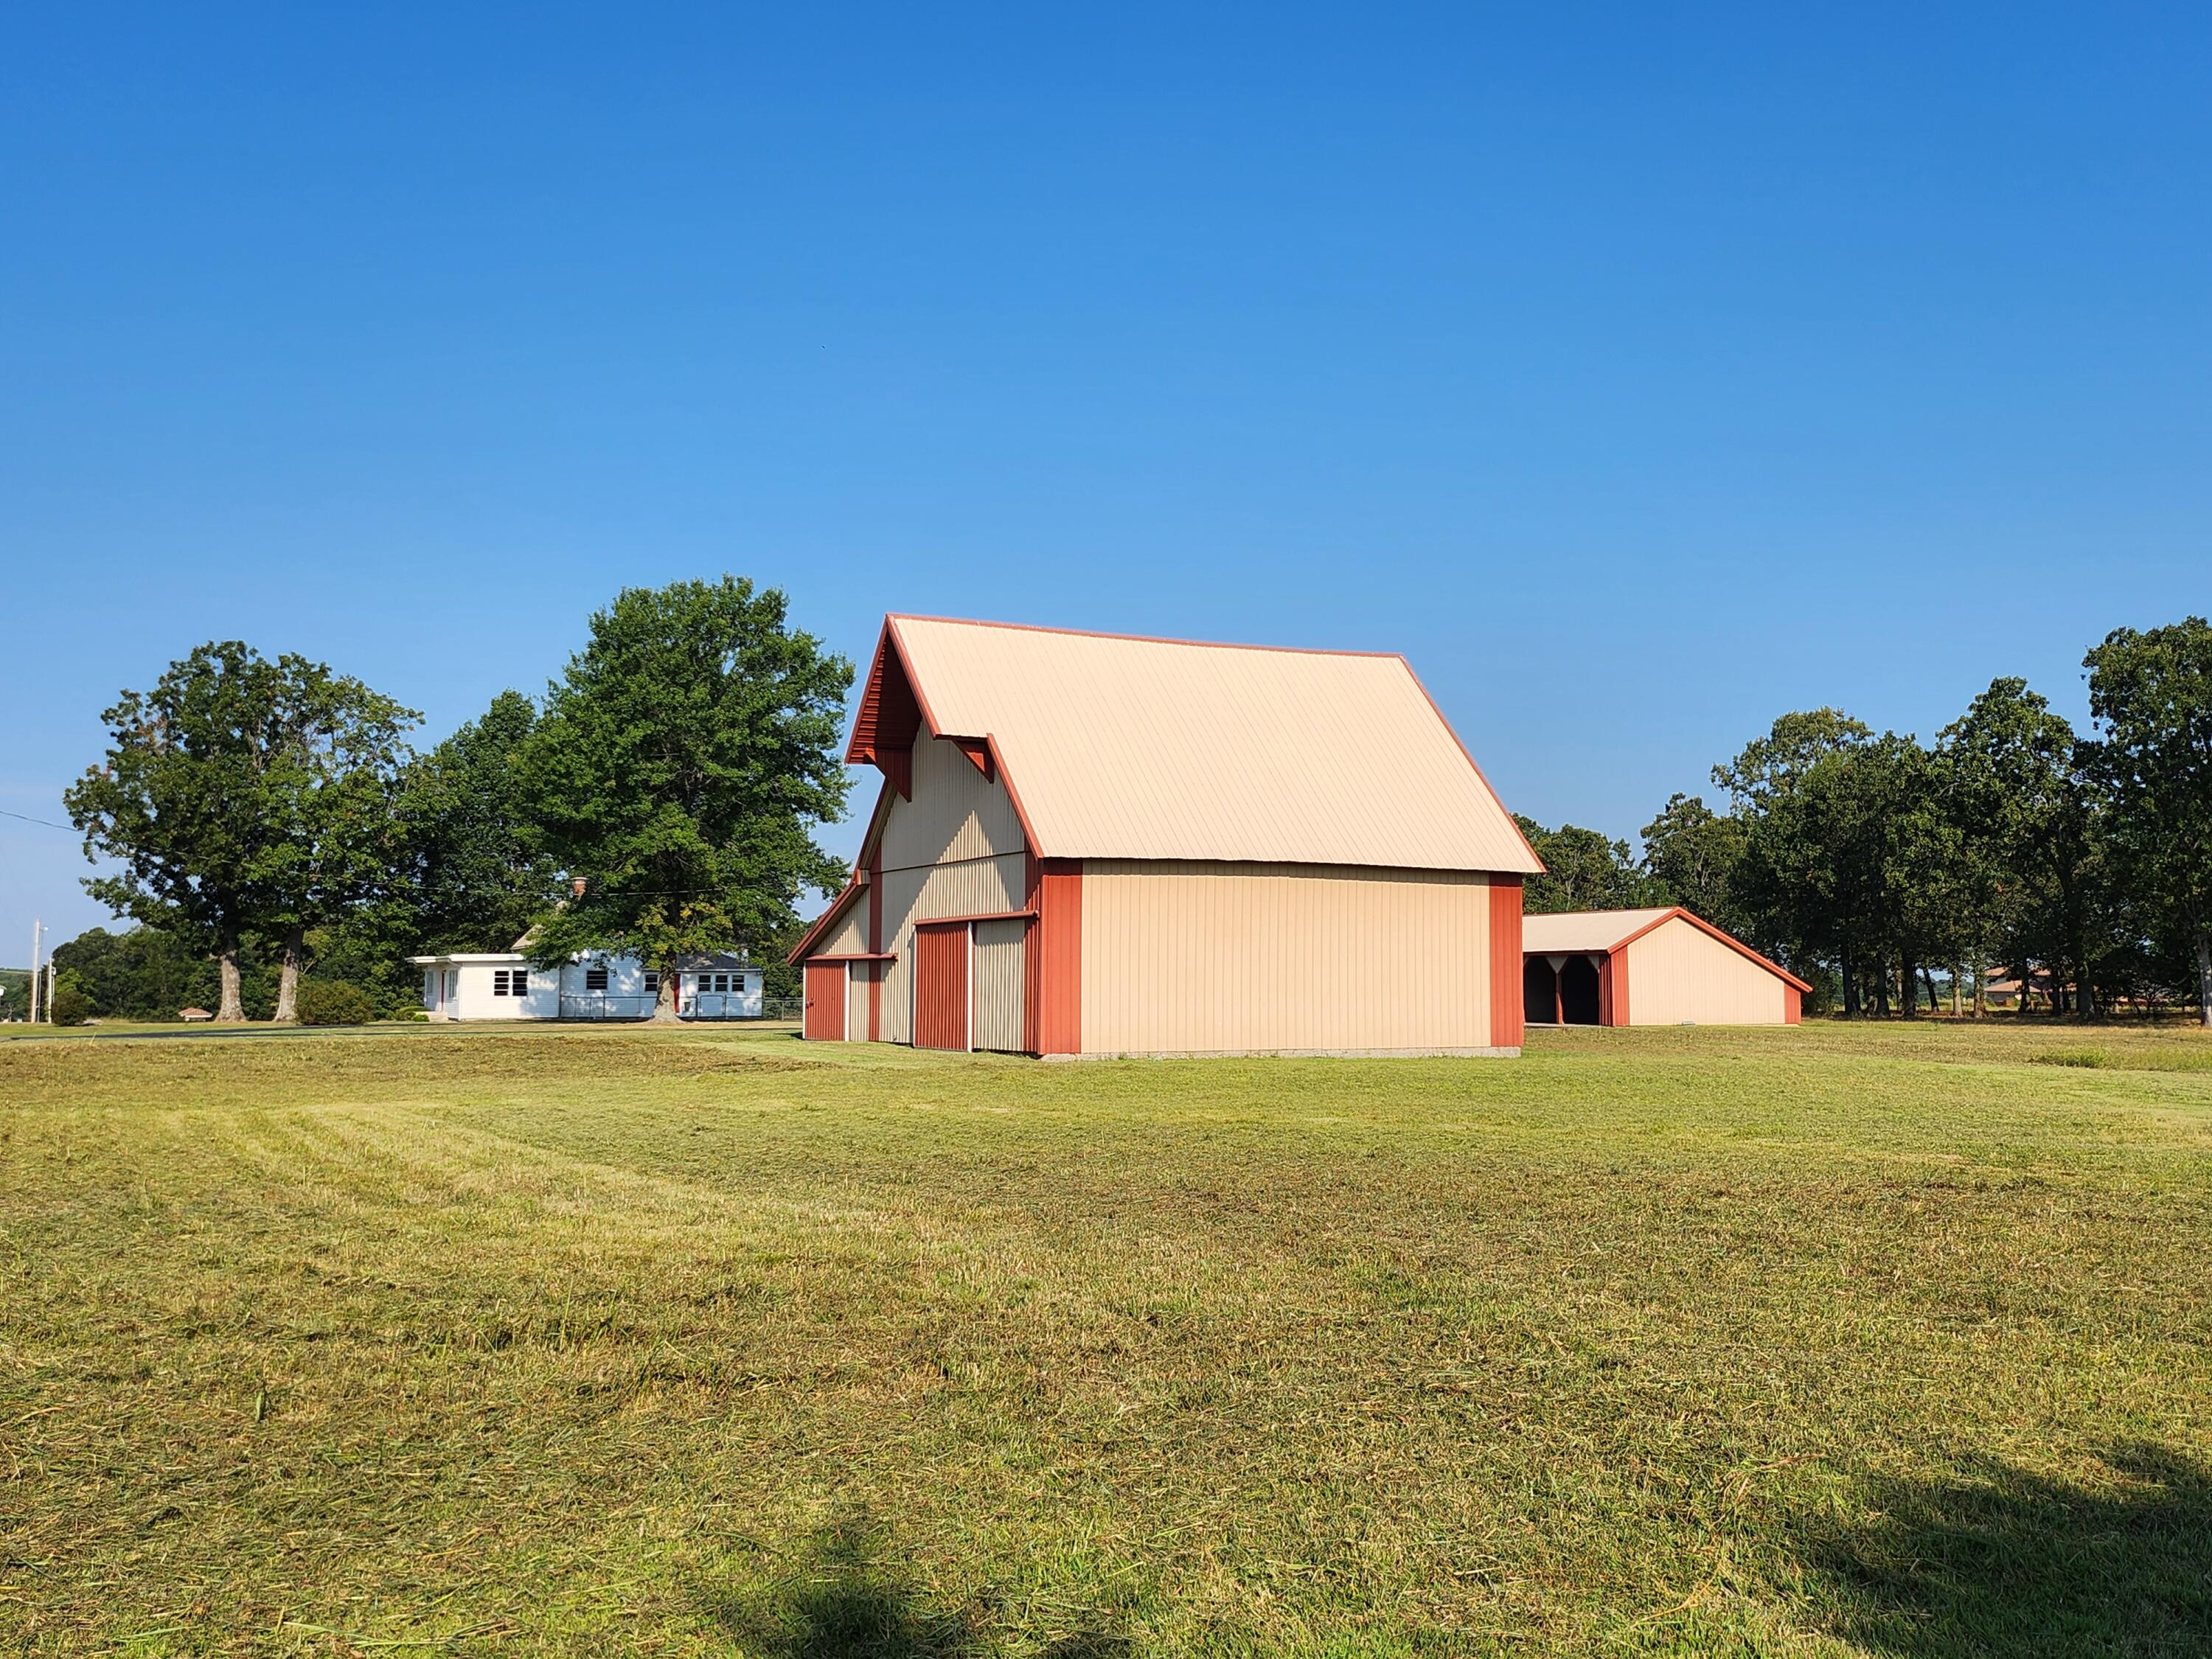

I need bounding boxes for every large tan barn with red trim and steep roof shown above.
[792,617,1542,1055]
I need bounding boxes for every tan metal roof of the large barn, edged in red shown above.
[856,617,1542,874]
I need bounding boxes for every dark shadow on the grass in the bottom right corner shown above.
[1805,1447,2212,1659]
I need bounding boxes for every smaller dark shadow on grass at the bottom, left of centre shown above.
[710,1522,1130,1659]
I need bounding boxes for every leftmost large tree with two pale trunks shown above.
[64,639,414,1022]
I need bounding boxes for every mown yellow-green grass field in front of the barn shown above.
[0,1024,2212,1659]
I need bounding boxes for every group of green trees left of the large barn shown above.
[53,575,854,1022]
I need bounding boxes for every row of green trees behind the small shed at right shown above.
[1520,617,2212,1024]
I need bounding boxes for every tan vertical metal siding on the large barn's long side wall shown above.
[1082,858,1520,1053]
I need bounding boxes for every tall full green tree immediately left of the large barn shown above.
[520,575,852,1020]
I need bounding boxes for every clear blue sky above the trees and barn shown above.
[0,4,2212,962]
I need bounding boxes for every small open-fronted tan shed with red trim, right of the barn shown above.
[1522,905,1812,1026]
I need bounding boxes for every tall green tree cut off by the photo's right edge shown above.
[2084,617,2212,1026]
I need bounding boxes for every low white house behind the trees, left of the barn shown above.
[407,940,763,1020]
